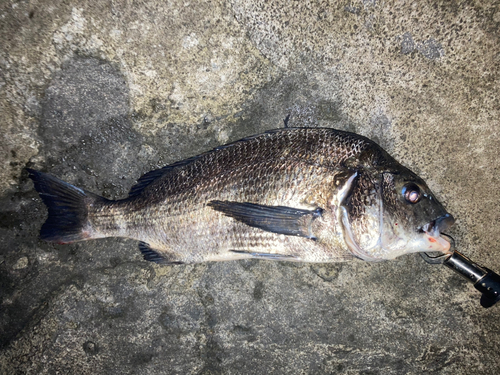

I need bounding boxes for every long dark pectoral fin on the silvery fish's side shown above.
[208,201,323,240]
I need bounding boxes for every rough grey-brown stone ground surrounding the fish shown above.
[0,0,500,374]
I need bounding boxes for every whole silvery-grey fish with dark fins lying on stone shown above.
[27,127,455,265]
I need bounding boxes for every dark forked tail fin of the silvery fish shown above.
[26,168,105,244]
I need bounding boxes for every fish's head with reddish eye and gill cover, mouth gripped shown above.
[341,164,455,261]
